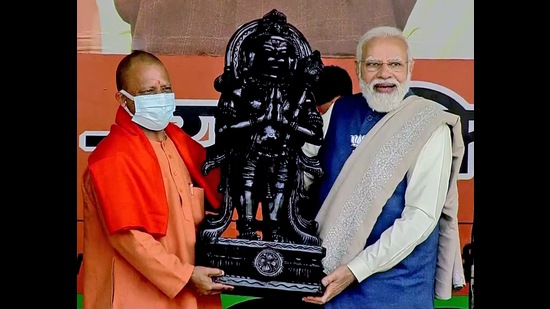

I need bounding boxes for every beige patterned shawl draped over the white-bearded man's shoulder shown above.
[315,95,465,299]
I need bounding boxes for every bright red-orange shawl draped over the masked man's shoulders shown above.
[88,107,221,236]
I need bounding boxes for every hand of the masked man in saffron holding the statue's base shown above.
[188,266,234,295]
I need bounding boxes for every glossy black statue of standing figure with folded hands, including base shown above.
[197,10,325,296]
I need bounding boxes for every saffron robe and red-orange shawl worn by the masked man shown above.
[83,109,221,309]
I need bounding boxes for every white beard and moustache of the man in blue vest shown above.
[359,74,410,113]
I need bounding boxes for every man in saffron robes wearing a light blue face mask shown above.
[83,51,233,309]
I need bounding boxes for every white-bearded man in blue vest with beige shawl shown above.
[303,26,465,309]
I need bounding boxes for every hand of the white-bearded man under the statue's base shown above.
[302,265,355,305]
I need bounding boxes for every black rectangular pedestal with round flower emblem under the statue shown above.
[196,237,326,298]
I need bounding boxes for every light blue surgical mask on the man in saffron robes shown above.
[120,90,176,131]
